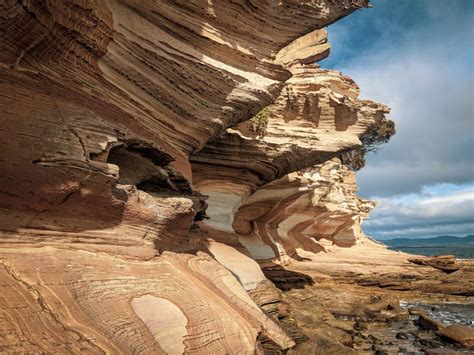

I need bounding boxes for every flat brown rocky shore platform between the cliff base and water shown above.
[266,245,474,354]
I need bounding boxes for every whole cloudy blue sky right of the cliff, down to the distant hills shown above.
[319,0,474,240]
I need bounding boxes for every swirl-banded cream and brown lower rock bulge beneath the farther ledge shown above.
[198,158,374,263]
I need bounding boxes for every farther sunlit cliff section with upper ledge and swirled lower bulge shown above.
[191,65,389,260]
